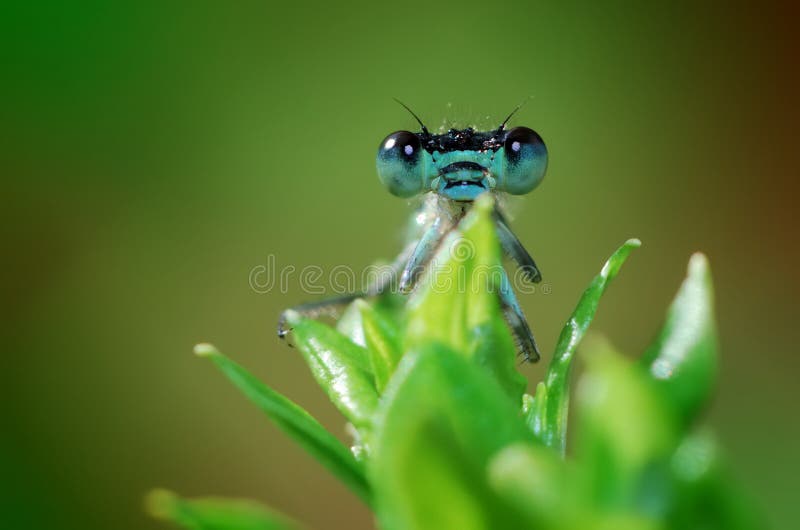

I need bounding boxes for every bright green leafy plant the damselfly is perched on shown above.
[149,200,761,530]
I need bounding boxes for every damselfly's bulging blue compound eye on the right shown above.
[495,127,547,195]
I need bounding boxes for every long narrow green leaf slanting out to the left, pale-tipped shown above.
[195,344,371,504]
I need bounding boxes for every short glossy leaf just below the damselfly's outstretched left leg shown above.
[288,315,378,428]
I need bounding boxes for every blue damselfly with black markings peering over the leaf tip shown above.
[278,103,547,361]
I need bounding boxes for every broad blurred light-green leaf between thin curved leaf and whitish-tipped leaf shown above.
[575,337,679,519]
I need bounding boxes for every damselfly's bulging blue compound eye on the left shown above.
[376,131,425,197]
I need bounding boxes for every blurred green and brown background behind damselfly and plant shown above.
[0,1,800,530]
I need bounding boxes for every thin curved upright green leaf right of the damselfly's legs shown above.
[531,239,641,454]
